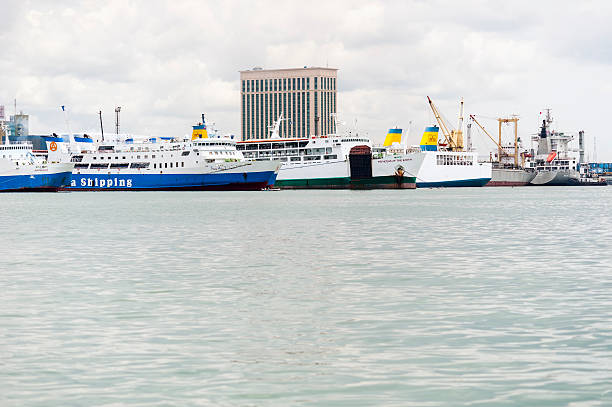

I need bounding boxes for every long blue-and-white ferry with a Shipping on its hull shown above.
[45,115,281,191]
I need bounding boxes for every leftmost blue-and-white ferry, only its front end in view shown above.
[0,123,74,192]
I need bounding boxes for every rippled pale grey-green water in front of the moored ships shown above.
[0,187,612,406]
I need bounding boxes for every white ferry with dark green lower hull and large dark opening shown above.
[236,115,422,189]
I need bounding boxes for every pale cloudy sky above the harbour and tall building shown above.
[0,0,612,161]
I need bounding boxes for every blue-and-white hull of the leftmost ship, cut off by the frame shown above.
[0,163,73,192]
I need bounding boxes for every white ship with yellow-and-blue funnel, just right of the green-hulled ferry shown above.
[381,126,492,188]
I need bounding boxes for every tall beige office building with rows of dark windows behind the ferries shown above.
[240,67,338,140]
